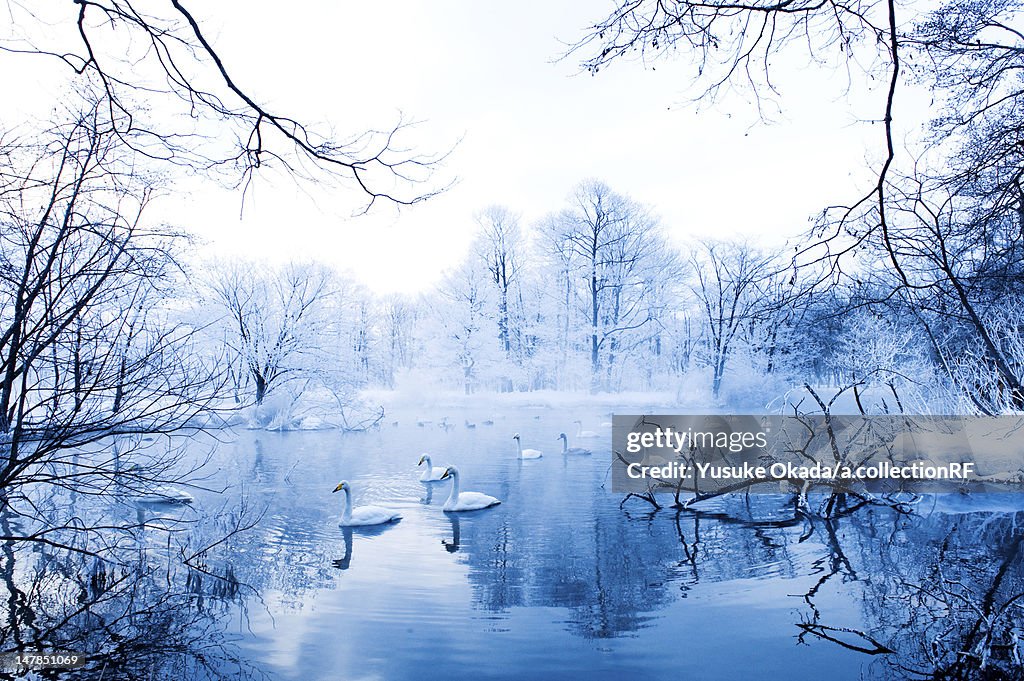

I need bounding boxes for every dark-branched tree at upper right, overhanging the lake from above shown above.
[574,0,1024,412]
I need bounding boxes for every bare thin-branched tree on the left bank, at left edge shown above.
[0,102,220,555]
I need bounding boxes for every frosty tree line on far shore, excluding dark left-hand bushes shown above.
[186,173,1022,421]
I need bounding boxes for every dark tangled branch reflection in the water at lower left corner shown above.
[0,501,260,680]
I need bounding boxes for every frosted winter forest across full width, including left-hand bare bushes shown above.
[14,135,1024,429]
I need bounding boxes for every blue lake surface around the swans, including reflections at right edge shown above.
[9,401,1024,680]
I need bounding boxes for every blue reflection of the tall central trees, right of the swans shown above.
[446,458,700,638]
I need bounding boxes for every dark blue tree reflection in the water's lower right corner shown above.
[797,497,1024,680]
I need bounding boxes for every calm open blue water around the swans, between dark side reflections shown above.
[153,409,1020,680]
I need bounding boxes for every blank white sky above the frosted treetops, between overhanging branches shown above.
[5,0,921,293]
